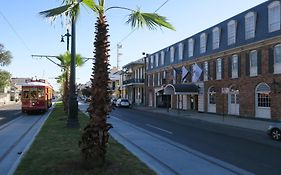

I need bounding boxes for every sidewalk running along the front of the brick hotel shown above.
[133,106,281,132]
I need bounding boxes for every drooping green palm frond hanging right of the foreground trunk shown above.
[126,10,175,30]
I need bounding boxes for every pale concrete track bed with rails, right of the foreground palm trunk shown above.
[109,116,253,175]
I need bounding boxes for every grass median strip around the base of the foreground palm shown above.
[15,103,155,175]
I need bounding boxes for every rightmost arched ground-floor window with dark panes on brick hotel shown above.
[256,83,270,107]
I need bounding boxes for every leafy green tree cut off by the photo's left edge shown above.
[0,43,12,89]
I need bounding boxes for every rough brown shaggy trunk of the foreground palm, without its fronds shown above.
[79,16,112,165]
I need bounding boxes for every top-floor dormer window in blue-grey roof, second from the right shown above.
[245,12,256,39]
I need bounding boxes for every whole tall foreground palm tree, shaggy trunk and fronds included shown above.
[40,0,174,165]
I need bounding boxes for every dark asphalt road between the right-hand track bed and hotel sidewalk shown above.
[110,108,281,175]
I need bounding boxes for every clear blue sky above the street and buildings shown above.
[0,0,266,89]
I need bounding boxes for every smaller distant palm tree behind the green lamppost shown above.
[56,51,84,113]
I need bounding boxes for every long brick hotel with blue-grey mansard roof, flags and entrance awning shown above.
[146,0,281,119]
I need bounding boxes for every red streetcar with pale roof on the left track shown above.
[21,79,53,113]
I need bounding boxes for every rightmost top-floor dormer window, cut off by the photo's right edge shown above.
[268,1,280,32]
